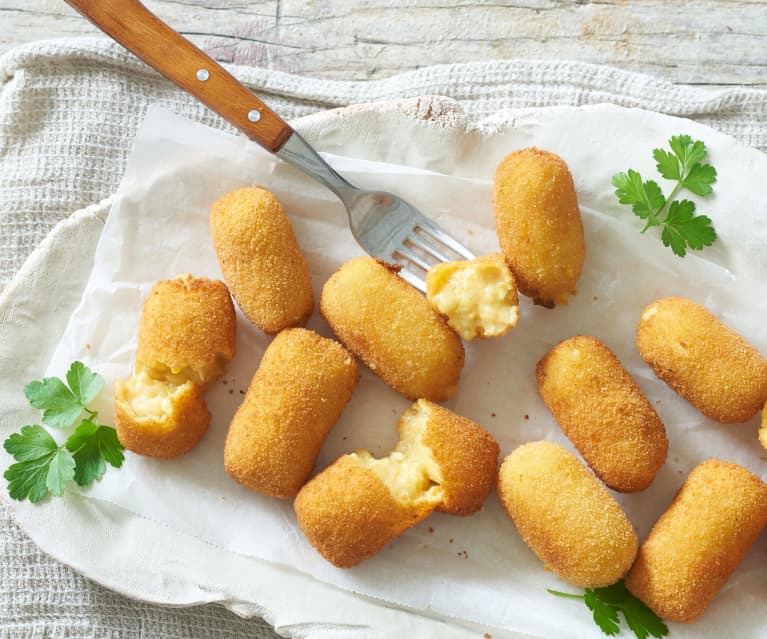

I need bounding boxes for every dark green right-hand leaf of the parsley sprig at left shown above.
[66,419,125,486]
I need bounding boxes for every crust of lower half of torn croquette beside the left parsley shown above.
[115,377,210,459]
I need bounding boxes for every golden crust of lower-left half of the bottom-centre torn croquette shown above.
[295,455,436,568]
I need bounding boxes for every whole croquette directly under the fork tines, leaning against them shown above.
[320,257,464,402]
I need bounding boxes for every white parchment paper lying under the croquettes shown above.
[48,109,767,638]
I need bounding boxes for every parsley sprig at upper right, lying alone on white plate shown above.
[612,135,716,257]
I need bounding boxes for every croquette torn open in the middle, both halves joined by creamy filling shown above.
[295,400,498,568]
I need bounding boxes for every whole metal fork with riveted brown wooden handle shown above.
[65,0,474,292]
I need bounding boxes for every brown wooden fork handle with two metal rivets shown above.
[65,0,293,153]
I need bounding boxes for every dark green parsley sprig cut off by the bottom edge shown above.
[548,580,668,639]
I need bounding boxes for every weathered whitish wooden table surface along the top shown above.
[0,0,767,87]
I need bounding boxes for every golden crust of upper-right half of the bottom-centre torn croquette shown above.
[416,399,500,515]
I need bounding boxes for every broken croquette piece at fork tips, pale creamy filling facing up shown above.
[426,253,519,341]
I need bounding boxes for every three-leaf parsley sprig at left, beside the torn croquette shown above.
[3,362,125,503]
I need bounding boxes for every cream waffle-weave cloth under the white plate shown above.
[0,39,767,639]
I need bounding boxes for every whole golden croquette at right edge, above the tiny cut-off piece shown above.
[636,297,767,424]
